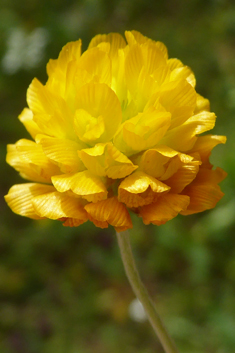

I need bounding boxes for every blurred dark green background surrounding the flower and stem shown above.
[0,0,235,353]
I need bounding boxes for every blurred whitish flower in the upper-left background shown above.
[2,27,49,75]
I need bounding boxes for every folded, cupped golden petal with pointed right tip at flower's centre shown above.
[79,143,138,179]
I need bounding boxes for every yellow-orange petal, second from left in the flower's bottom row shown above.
[32,188,88,224]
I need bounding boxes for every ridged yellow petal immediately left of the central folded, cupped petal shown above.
[37,135,85,173]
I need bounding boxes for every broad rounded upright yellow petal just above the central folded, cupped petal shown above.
[75,83,122,145]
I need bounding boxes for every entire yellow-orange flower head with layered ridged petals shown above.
[5,31,226,231]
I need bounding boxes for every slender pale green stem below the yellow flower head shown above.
[117,231,177,353]
